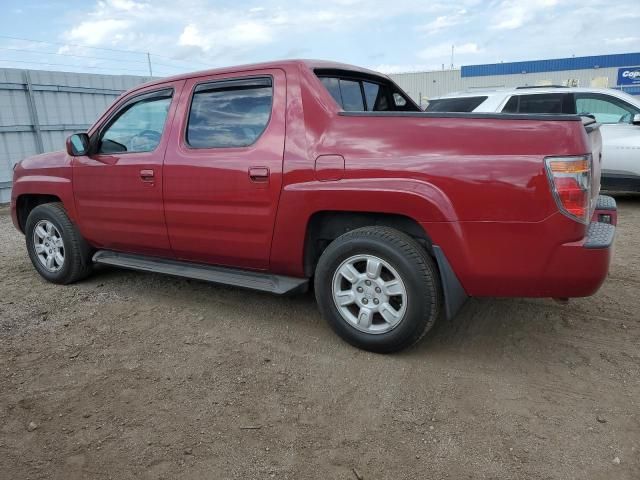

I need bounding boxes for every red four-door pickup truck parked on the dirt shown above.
[12,61,616,352]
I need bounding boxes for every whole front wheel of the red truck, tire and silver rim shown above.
[25,203,91,284]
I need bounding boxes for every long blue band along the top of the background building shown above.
[460,52,640,78]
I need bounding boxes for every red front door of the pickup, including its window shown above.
[73,81,184,256]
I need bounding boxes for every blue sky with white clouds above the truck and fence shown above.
[0,0,640,76]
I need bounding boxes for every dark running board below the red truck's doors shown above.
[93,250,309,294]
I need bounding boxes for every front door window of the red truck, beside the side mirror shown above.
[98,90,172,154]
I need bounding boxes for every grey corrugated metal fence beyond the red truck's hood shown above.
[0,68,150,203]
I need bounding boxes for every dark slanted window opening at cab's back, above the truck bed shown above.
[316,71,420,112]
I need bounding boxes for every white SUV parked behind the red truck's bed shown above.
[426,86,640,192]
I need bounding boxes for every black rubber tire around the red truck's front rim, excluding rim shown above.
[25,203,92,285]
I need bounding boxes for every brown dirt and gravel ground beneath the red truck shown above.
[0,197,640,480]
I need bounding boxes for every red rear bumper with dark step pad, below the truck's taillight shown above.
[422,196,617,297]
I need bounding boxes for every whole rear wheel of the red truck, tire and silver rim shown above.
[315,227,442,353]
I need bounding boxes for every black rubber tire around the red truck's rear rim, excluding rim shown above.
[314,227,442,353]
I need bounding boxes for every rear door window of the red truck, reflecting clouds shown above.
[186,77,273,148]
